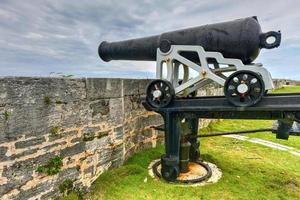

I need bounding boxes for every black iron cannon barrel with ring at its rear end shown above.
[98,17,281,64]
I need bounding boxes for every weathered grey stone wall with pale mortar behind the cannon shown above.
[0,77,296,200]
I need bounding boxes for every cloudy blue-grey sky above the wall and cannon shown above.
[0,0,300,80]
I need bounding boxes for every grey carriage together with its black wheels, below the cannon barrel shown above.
[151,45,274,107]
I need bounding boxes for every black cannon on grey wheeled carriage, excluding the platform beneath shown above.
[98,17,281,107]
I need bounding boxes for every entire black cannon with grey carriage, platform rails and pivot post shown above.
[98,17,300,183]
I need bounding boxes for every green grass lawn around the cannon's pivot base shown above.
[62,87,300,200]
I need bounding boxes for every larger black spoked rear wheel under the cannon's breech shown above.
[224,70,265,107]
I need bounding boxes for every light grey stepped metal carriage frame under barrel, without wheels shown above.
[156,45,274,96]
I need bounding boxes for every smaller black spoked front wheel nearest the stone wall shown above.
[146,80,175,108]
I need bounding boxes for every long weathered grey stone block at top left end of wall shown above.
[0,77,86,104]
